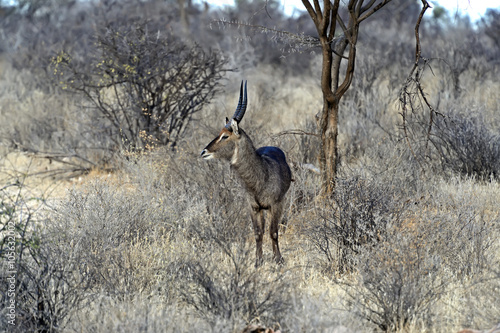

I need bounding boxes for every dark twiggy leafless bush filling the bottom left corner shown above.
[0,183,91,332]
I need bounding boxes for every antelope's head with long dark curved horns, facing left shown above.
[201,81,247,160]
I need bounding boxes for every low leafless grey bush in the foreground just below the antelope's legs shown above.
[176,218,292,328]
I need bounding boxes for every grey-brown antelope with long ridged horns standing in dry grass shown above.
[201,81,292,267]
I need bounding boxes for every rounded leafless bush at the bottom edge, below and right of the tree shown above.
[350,214,451,332]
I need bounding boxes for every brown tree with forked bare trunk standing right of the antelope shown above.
[302,0,428,195]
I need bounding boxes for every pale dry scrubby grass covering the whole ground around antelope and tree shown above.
[0,2,500,333]
